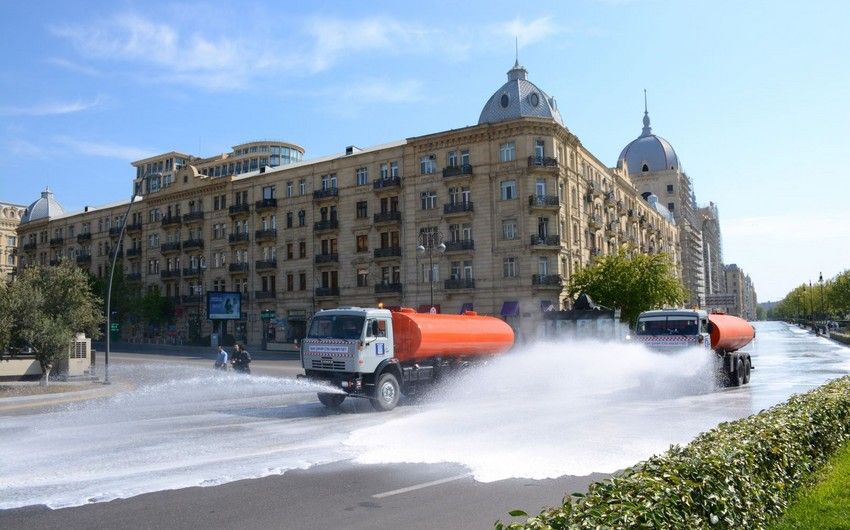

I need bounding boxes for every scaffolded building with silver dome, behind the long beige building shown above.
[617,102,708,307]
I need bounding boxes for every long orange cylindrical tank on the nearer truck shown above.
[392,307,514,361]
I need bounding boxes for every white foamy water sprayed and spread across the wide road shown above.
[0,323,850,508]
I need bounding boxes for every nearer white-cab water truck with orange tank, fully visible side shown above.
[301,307,514,411]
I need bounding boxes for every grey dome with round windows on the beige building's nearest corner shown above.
[478,61,564,127]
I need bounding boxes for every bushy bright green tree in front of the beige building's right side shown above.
[568,245,685,325]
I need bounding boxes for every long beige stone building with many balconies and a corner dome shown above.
[19,62,680,349]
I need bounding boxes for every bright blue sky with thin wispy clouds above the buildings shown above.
[0,0,850,300]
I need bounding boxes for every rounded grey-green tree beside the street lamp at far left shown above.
[3,260,103,385]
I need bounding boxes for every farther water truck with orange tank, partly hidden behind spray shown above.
[635,309,756,386]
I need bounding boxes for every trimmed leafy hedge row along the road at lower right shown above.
[496,376,850,530]
